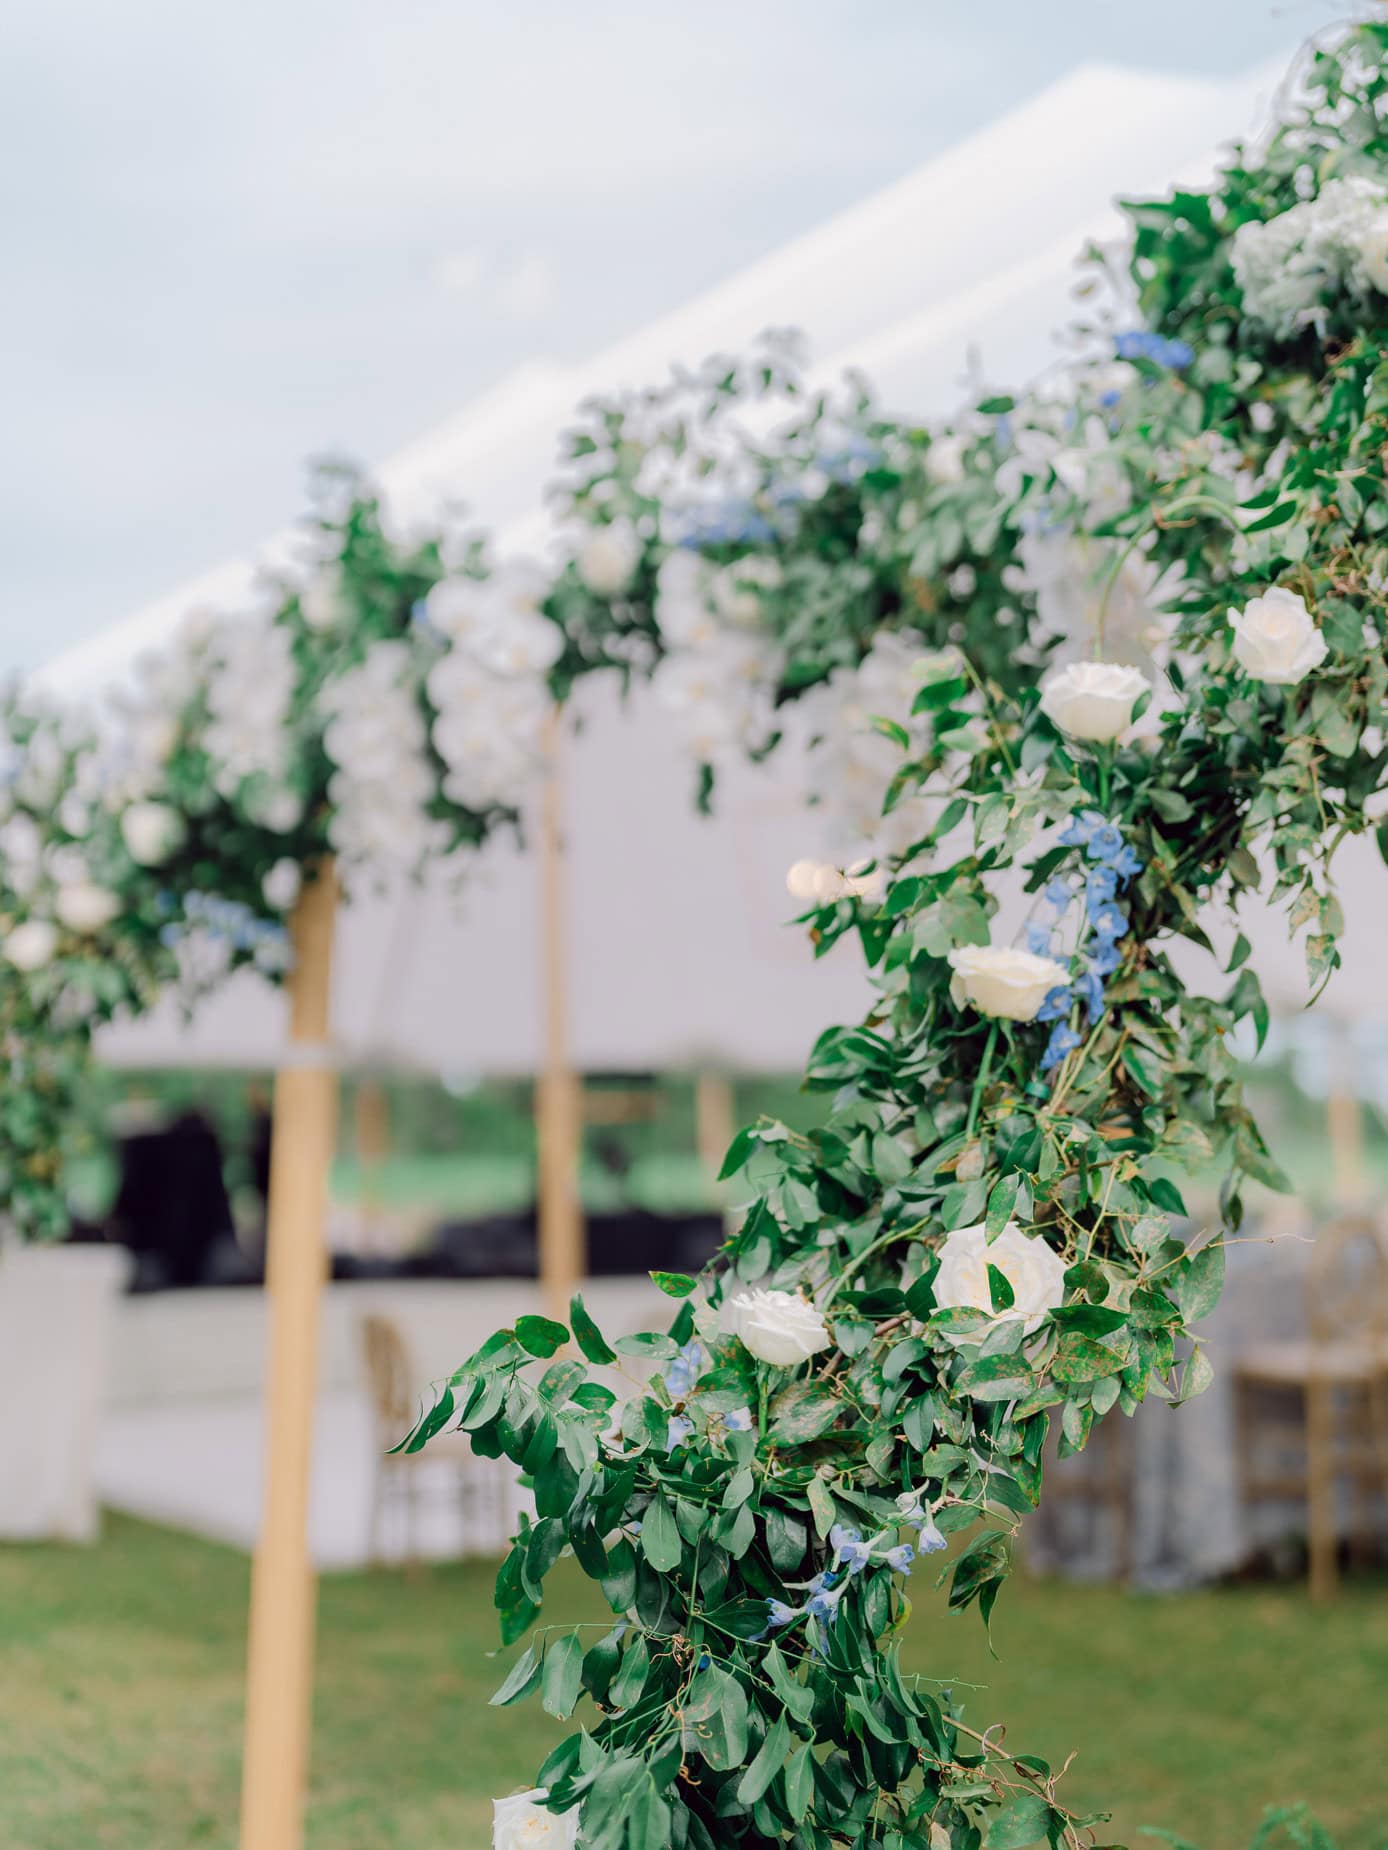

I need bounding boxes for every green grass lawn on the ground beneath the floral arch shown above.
[0,1519,1388,1850]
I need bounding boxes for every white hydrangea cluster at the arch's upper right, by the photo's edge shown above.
[1231,174,1388,340]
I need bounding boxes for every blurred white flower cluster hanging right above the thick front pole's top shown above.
[320,640,440,871]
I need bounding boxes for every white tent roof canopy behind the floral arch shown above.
[51,50,1382,1071]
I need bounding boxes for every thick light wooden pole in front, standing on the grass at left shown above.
[241,862,337,1850]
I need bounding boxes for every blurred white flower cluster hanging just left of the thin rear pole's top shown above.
[424,562,564,810]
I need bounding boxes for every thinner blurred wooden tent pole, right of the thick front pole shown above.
[537,712,587,1317]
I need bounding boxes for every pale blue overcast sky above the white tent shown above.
[0,0,1332,670]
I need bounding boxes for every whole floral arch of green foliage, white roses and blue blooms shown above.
[0,24,1388,1850]
